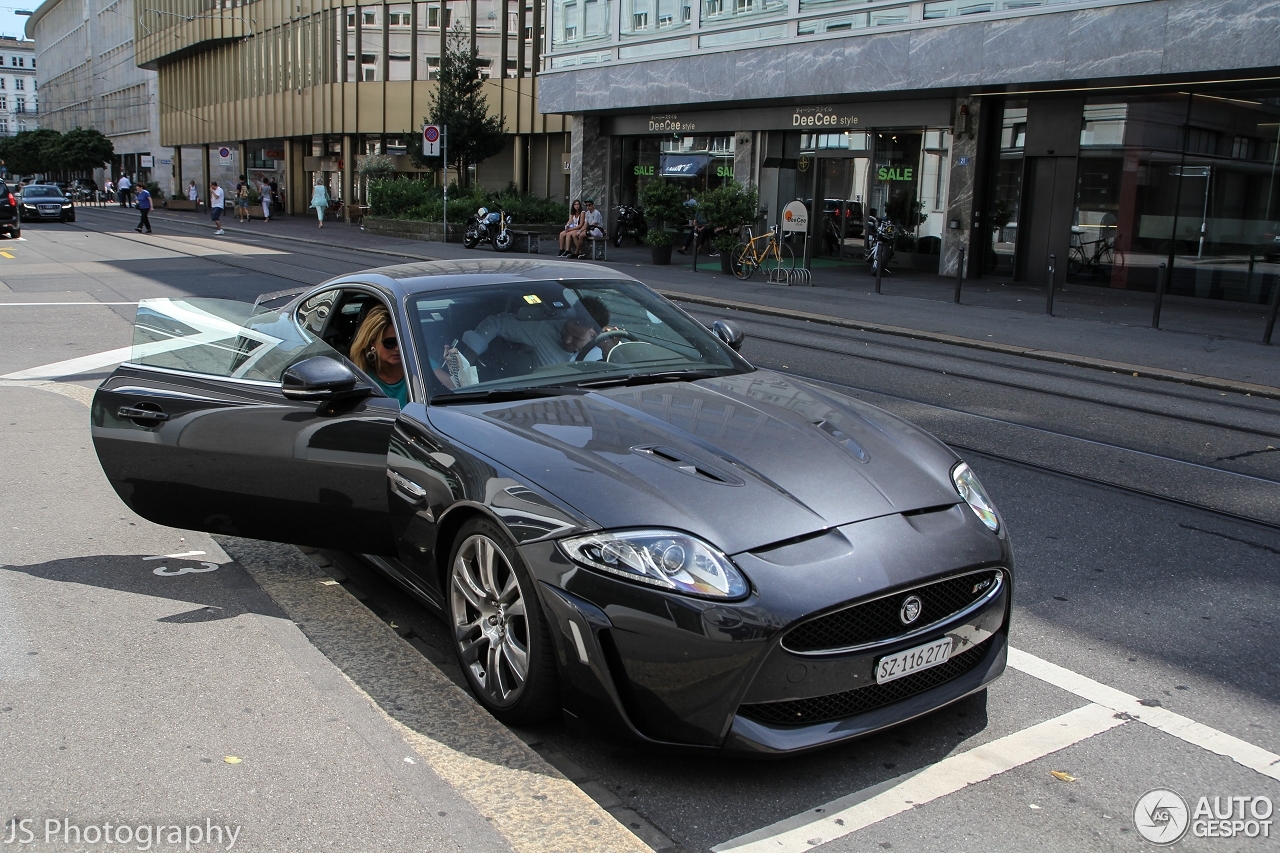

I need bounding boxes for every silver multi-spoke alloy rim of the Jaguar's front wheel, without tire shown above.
[449,534,529,707]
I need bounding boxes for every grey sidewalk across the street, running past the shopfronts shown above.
[81,207,1280,398]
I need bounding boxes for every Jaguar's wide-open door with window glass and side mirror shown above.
[92,298,399,555]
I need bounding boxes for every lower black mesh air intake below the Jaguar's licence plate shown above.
[737,638,995,726]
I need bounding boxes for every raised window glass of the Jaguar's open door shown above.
[129,298,343,383]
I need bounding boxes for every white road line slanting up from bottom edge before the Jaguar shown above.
[712,703,1125,853]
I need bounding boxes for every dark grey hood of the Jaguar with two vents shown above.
[429,370,960,553]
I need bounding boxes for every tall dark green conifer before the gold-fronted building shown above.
[412,24,507,186]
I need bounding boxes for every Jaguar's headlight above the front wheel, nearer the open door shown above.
[559,530,750,598]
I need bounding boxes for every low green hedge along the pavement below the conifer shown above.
[369,178,568,225]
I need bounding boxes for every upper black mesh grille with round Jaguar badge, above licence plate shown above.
[782,569,1001,653]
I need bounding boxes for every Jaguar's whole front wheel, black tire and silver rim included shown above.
[448,519,559,725]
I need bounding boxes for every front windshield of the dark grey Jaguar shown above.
[408,279,753,401]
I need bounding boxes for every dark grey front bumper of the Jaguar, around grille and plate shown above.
[522,508,1012,756]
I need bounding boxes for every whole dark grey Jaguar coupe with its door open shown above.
[92,260,1012,754]
